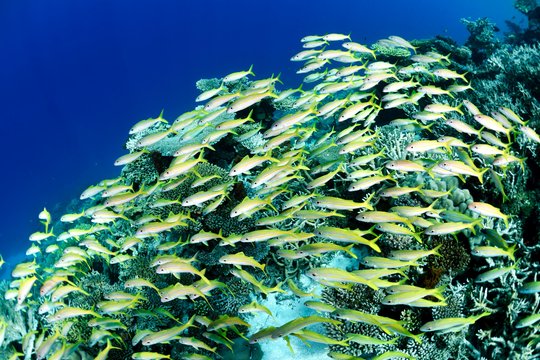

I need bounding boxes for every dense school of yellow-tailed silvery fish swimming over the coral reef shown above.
[0,34,540,359]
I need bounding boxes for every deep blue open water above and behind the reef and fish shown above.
[0,0,525,257]
